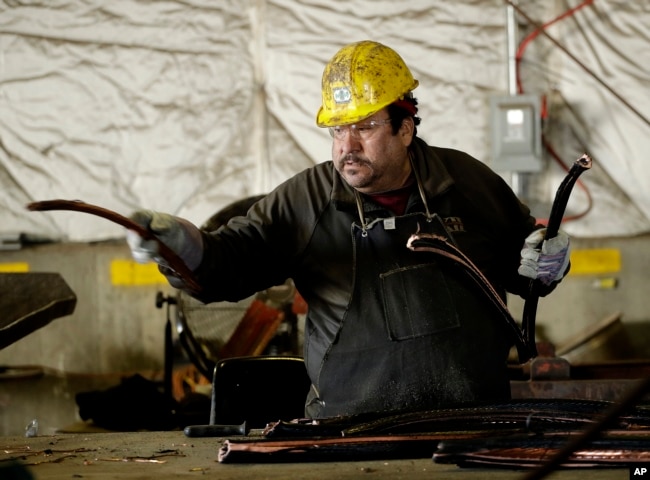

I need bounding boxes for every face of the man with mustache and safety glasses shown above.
[332,109,414,193]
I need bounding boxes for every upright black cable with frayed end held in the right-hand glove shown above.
[522,153,592,357]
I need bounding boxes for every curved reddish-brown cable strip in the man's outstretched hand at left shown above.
[27,200,201,292]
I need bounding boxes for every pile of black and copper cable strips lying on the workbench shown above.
[219,399,650,467]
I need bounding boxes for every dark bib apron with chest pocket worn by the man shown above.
[306,213,512,418]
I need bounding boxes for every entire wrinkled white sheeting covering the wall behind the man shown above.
[0,0,650,241]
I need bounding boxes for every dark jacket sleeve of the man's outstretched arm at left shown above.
[187,167,329,303]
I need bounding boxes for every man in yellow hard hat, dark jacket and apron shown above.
[129,41,569,418]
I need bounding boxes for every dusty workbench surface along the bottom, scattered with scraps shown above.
[0,431,630,480]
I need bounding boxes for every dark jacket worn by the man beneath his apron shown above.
[196,138,552,408]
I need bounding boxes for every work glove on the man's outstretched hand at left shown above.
[126,210,203,288]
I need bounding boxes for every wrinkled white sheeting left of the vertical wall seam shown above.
[0,1,284,240]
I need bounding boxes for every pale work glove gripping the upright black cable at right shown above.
[518,228,570,285]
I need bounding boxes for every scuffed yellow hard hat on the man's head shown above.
[316,40,418,127]
